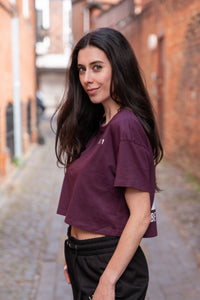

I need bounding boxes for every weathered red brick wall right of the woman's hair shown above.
[122,0,200,177]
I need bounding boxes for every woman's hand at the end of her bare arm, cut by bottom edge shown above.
[92,280,115,300]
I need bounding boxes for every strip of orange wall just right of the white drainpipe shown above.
[20,0,37,152]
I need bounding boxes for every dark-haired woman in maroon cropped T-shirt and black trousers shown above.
[56,28,163,300]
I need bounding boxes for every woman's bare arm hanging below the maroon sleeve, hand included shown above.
[93,188,151,300]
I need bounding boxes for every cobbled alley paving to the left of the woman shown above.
[0,121,71,300]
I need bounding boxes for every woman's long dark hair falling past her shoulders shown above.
[55,28,163,173]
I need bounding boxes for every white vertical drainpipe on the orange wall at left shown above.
[9,0,22,162]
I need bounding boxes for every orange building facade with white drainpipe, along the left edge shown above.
[0,0,37,178]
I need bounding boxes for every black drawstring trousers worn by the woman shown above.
[65,230,149,300]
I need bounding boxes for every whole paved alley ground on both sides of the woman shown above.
[0,121,200,300]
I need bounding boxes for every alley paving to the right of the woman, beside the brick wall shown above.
[143,162,200,300]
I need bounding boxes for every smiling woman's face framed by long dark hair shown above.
[78,46,113,105]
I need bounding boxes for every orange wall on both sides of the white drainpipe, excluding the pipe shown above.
[0,0,37,177]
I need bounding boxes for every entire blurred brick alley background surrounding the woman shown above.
[0,0,200,300]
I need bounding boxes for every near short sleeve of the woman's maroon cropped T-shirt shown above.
[114,140,150,192]
